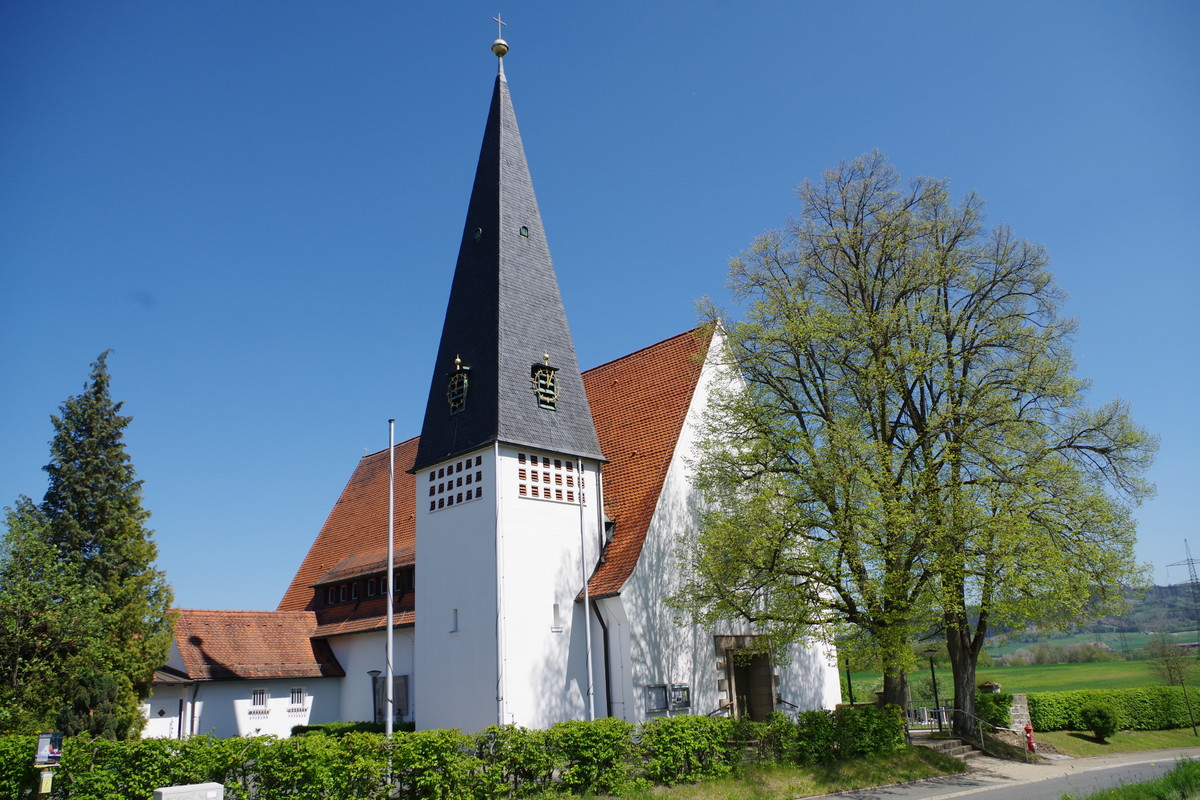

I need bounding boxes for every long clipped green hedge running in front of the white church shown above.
[0,706,905,800]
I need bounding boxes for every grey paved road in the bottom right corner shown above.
[820,747,1200,800]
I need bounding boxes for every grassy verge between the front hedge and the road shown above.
[600,747,966,800]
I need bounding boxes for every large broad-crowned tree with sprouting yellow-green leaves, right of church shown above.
[676,152,1156,733]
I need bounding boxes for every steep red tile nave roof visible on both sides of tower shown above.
[271,330,709,636]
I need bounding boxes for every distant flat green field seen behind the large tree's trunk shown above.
[852,661,1162,702]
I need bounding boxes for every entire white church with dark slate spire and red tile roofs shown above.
[143,35,839,738]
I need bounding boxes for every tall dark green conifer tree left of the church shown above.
[0,351,173,738]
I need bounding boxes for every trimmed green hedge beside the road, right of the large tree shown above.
[1028,686,1200,730]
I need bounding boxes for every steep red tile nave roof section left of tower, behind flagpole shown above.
[278,438,416,614]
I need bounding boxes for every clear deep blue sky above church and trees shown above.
[0,0,1200,608]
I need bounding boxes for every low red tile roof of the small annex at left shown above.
[175,608,346,680]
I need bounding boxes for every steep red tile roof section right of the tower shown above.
[583,329,709,597]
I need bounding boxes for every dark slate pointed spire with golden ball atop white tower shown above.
[413,38,602,470]
